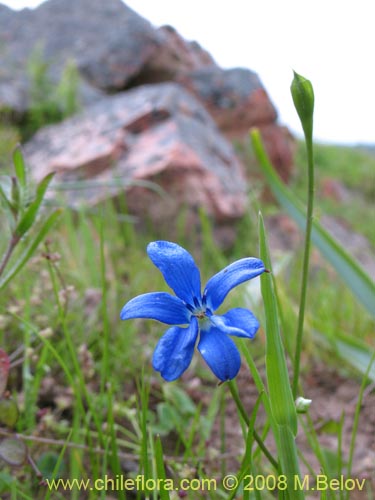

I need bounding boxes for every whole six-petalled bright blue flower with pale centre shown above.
[120,241,265,381]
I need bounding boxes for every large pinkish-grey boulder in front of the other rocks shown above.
[25,83,250,221]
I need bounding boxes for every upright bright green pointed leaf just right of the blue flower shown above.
[259,214,297,435]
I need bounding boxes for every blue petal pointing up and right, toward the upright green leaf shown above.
[203,257,265,311]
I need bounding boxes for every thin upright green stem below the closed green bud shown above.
[292,131,315,399]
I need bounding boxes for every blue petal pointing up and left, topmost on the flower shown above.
[147,241,201,307]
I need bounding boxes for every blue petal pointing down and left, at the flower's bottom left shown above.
[152,317,198,382]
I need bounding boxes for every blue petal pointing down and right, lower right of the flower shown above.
[198,326,241,382]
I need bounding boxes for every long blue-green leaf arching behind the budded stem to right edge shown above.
[251,130,375,315]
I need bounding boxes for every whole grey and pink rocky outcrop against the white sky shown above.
[0,0,298,225]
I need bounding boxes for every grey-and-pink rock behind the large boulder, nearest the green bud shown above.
[177,66,294,182]
